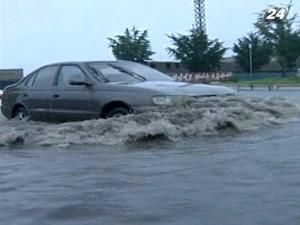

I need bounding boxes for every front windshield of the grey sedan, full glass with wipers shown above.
[88,62,174,83]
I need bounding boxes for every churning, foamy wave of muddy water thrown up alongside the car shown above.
[0,96,300,146]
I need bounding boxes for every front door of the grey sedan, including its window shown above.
[51,65,97,121]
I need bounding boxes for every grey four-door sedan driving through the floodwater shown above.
[1,61,234,121]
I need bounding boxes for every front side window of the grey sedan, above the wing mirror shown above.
[58,66,86,87]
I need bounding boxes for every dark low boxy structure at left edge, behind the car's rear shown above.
[0,69,23,90]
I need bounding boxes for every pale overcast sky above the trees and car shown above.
[0,0,300,73]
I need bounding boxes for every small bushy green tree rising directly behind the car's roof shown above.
[108,27,154,63]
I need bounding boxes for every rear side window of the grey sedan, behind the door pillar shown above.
[33,66,58,88]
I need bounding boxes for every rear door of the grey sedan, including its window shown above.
[21,66,59,120]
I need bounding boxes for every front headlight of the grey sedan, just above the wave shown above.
[152,95,192,106]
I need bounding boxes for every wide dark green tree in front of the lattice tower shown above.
[167,29,226,72]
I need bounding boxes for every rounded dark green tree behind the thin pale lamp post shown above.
[233,33,272,71]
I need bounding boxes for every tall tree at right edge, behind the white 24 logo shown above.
[255,3,300,75]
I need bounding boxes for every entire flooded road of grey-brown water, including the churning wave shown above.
[0,92,300,225]
